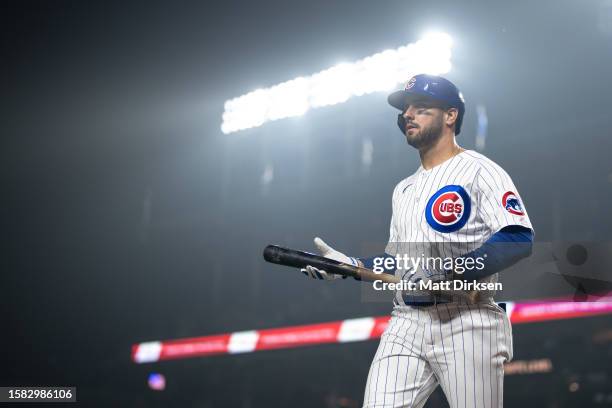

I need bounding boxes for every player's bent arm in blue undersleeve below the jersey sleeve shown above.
[454,226,533,281]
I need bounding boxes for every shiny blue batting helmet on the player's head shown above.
[387,74,465,135]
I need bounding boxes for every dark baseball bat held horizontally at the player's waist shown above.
[263,245,400,283]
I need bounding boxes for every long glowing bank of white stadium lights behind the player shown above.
[221,33,452,134]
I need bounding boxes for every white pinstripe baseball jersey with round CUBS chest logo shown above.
[385,150,532,304]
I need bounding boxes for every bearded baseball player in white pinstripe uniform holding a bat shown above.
[302,75,533,408]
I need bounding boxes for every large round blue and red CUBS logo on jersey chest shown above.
[425,184,471,232]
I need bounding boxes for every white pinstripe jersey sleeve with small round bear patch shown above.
[476,164,533,235]
